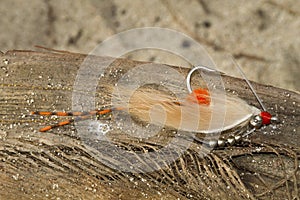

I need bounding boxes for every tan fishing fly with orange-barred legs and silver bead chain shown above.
[31,65,278,147]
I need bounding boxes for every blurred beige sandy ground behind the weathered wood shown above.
[0,0,300,91]
